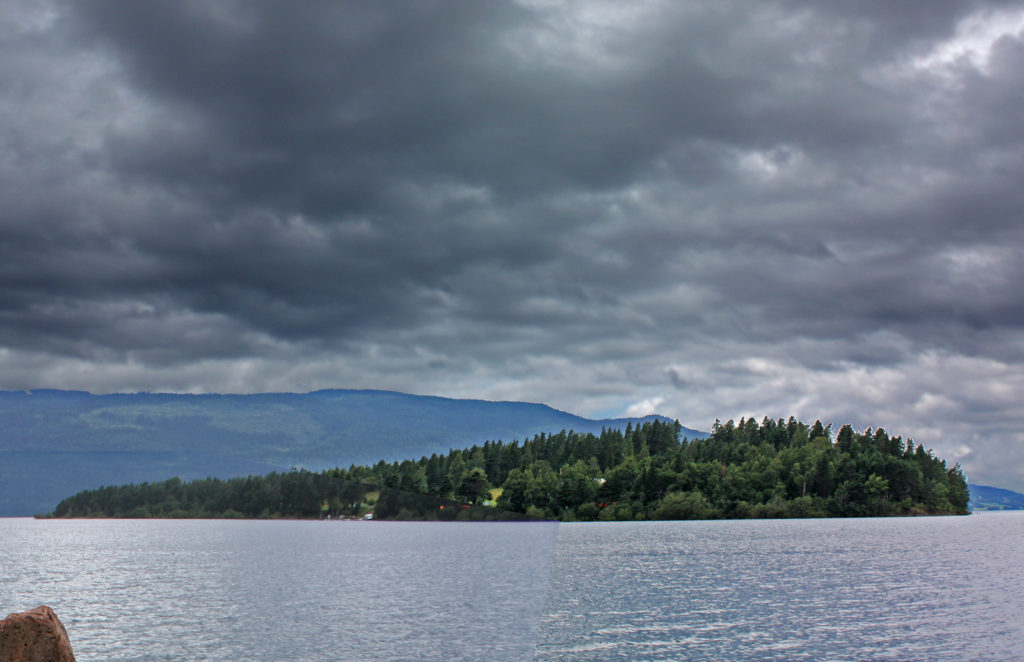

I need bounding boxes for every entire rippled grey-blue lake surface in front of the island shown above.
[0,512,1024,662]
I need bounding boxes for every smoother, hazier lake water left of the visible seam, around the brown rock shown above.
[0,520,558,662]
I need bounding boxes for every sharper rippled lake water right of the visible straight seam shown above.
[537,512,1024,661]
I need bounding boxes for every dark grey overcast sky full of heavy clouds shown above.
[0,0,1024,490]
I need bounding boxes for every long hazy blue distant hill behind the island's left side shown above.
[0,390,707,516]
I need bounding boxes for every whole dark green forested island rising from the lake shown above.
[52,417,968,521]
